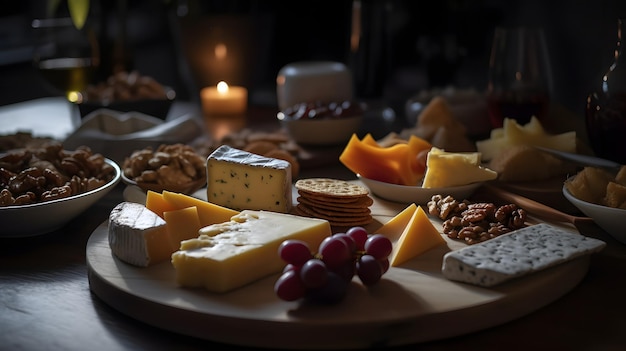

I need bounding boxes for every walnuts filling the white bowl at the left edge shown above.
[0,142,115,207]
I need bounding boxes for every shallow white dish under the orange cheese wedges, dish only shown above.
[357,174,483,205]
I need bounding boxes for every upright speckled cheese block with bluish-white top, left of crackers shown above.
[207,145,292,213]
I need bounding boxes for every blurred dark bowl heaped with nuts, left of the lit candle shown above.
[77,71,176,120]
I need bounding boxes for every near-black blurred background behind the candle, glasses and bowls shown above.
[0,0,626,121]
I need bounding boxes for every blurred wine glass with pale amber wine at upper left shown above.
[32,17,99,103]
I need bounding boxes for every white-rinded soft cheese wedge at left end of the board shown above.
[108,202,175,267]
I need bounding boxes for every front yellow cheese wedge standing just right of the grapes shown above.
[389,207,446,267]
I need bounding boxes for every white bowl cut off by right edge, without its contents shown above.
[563,185,626,244]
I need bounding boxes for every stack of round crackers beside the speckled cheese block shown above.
[295,178,374,227]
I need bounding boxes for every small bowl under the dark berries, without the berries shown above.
[279,113,363,145]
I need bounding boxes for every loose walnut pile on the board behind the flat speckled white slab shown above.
[428,195,528,245]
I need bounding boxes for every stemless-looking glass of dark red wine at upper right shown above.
[487,27,552,128]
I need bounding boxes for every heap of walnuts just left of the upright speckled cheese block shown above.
[122,144,206,195]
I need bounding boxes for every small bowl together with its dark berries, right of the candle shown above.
[276,101,365,145]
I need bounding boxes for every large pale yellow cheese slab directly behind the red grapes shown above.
[172,210,331,293]
